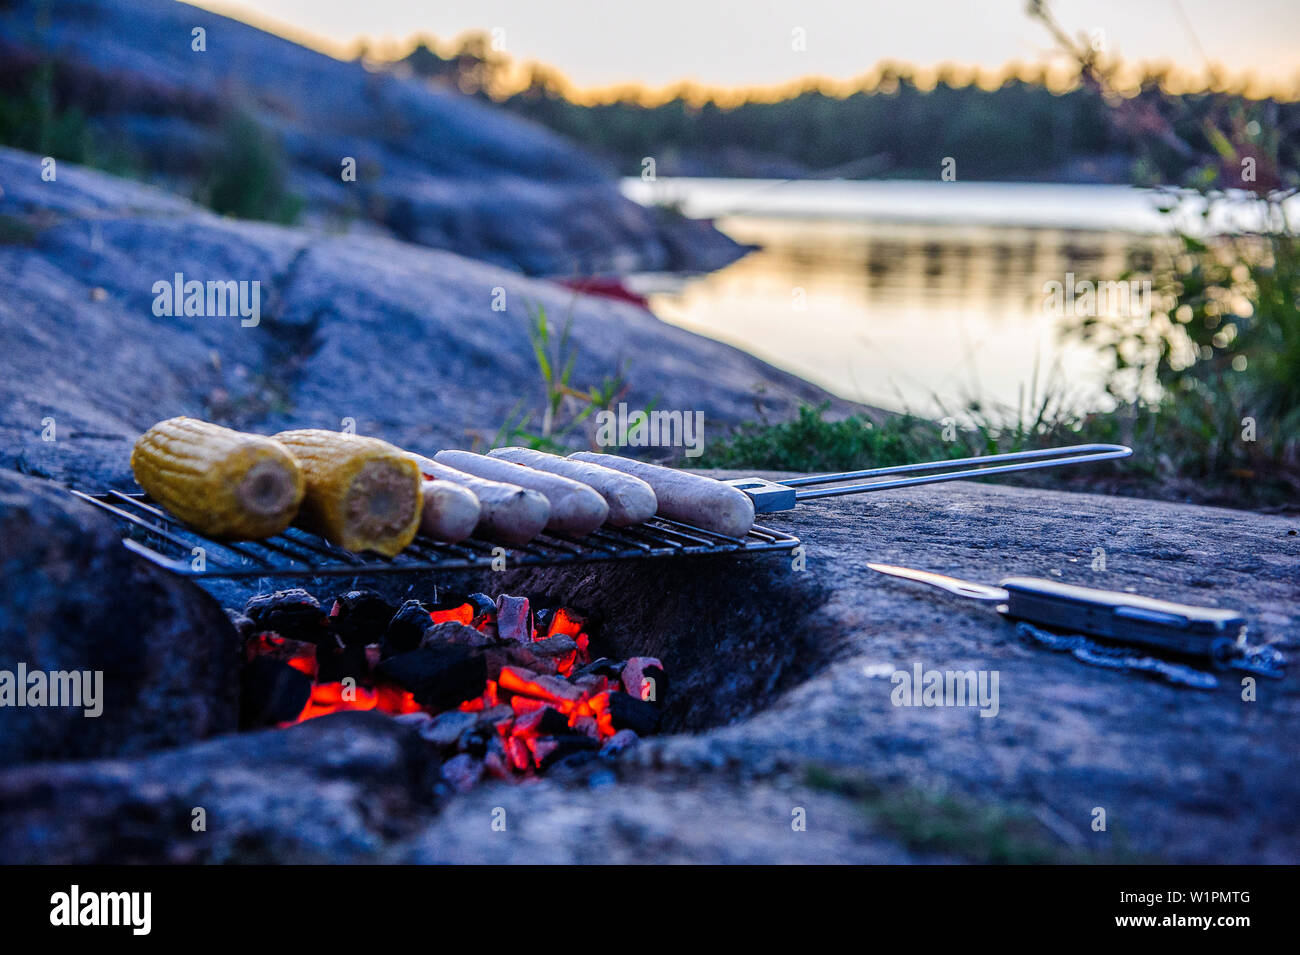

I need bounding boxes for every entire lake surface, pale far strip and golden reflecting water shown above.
[624,179,1190,414]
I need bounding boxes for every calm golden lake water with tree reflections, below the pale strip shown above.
[639,216,1153,414]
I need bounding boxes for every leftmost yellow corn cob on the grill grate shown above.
[131,418,304,541]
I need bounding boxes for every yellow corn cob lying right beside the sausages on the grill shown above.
[276,429,423,557]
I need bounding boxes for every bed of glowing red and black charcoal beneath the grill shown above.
[235,589,667,791]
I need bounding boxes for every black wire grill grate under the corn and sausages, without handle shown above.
[73,490,800,577]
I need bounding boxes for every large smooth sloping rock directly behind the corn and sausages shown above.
[0,149,846,487]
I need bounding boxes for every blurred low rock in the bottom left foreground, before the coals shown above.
[0,713,434,864]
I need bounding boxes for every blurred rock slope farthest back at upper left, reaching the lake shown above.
[0,0,744,277]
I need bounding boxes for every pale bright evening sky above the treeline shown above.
[198,0,1300,90]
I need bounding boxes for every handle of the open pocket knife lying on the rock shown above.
[998,577,1245,656]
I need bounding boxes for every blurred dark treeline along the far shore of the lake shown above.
[402,34,1300,183]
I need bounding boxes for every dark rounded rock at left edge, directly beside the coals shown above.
[0,472,239,765]
